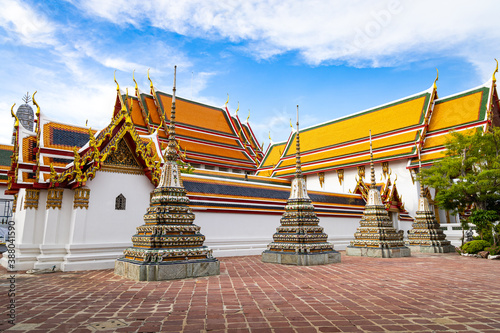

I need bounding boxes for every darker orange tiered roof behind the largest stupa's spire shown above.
[128,90,263,171]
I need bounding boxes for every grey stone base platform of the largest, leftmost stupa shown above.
[115,259,220,281]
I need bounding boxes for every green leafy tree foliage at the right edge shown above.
[420,128,500,213]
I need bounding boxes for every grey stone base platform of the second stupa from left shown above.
[262,251,340,266]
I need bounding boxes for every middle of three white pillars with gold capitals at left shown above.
[34,188,66,269]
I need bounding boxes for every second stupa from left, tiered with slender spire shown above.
[262,105,340,266]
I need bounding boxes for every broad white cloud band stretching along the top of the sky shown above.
[74,0,500,78]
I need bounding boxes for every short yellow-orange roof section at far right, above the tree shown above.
[409,80,500,168]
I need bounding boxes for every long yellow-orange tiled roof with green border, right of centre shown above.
[259,87,436,177]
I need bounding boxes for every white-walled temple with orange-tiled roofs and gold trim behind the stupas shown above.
[0,66,500,271]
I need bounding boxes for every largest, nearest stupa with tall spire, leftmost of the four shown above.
[115,67,220,281]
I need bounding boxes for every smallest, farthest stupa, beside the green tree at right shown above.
[406,154,455,253]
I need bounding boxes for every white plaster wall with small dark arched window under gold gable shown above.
[83,171,154,244]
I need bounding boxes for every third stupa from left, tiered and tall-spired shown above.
[346,131,411,258]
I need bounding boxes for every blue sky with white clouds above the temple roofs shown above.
[0,0,500,146]
